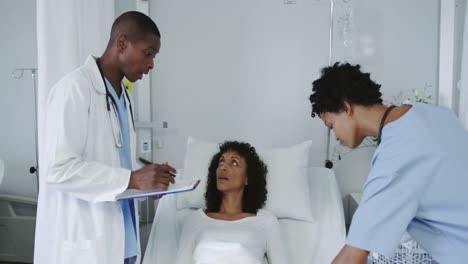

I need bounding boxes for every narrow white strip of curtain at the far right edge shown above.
[458,2,468,130]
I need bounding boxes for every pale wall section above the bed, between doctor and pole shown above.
[150,0,330,167]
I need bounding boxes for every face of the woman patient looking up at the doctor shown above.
[216,151,247,192]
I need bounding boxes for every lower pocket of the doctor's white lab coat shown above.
[60,237,107,264]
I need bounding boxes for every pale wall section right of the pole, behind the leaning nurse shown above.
[334,0,439,198]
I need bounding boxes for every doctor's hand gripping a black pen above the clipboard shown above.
[128,163,176,191]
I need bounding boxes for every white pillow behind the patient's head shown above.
[177,137,314,222]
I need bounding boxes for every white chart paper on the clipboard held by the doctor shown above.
[117,180,200,200]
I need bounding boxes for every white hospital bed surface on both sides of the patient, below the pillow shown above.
[143,167,346,264]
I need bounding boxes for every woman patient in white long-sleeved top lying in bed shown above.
[176,141,286,264]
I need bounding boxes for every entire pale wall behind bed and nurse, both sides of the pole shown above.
[150,0,439,200]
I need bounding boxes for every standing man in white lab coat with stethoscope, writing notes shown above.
[34,11,175,264]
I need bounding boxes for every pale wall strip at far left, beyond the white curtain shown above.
[0,0,37,197]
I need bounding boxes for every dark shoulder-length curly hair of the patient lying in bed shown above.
[205,141,268,213]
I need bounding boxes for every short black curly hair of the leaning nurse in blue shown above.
[309,62,382,117]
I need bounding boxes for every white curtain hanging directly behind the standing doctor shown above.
[37,0,115,186]
